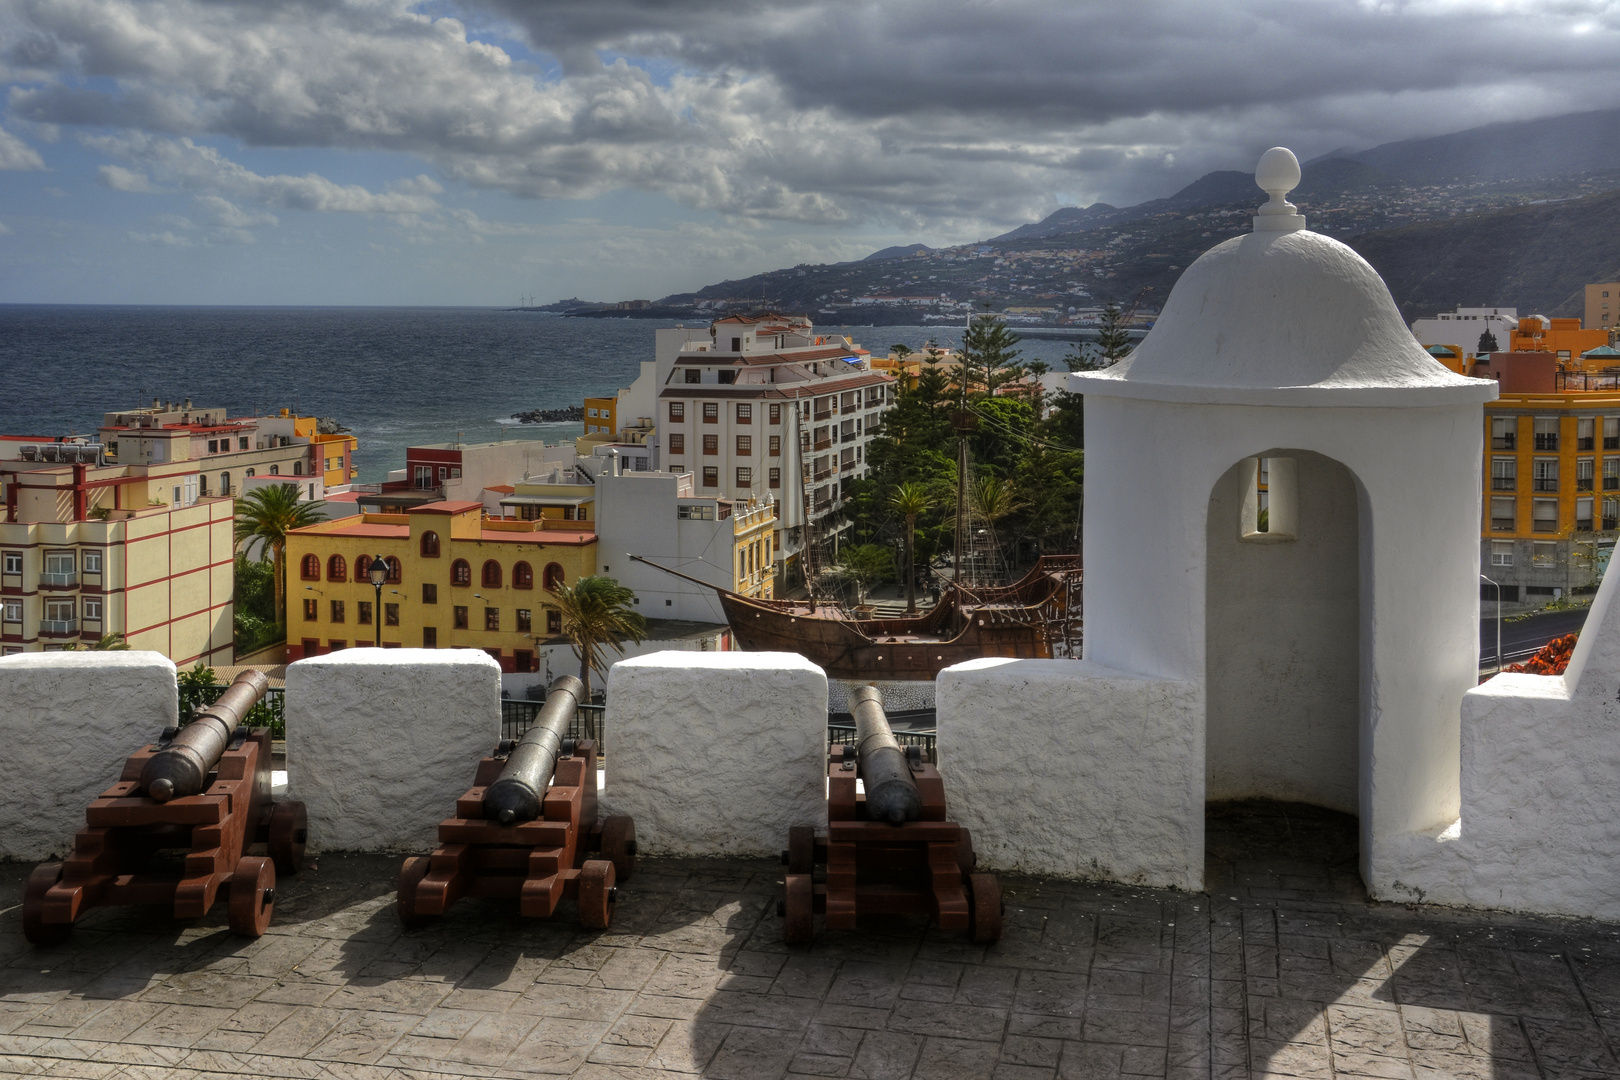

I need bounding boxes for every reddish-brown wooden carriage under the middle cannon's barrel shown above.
[399,740,635,929]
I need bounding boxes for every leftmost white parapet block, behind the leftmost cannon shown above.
[0,651,180,860]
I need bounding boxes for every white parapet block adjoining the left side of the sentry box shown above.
[935,657,1204,889]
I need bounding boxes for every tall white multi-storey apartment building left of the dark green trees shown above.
[651,313,896,591]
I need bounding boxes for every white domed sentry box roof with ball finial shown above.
[1071,146,1497,408]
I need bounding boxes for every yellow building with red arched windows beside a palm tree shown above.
[287,502,596,672]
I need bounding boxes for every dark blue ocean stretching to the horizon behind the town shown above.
[0,304,1088,483]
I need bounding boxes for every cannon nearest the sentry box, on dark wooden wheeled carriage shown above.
[776,687,1001,944]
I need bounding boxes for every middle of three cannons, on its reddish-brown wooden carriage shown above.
[397,675,635,929]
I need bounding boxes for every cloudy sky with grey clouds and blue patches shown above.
[0,0,1620,304]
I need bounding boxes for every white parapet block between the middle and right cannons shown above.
[603,653,826,857]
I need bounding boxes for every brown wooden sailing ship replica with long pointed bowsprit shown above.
[632,555,1081,680]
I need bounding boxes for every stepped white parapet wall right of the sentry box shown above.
[1392,575,1620,920]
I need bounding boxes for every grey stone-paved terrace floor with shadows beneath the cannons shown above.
[0,803,1620,1080]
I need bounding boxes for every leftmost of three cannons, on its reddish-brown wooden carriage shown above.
[23,670,308,946]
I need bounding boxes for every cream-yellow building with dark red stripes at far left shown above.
[0,436,235,667]
